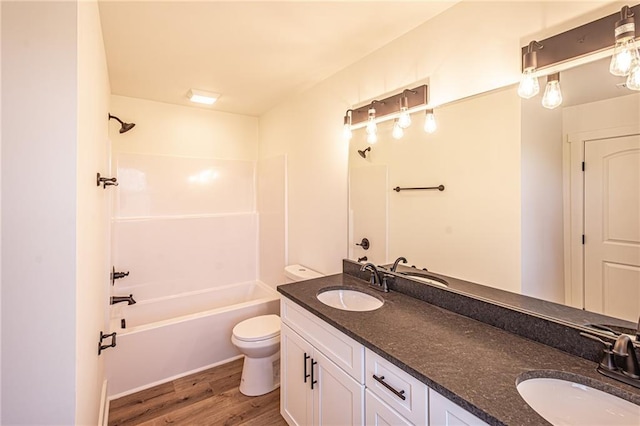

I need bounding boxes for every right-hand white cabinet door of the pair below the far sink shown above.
[312,350,364,426]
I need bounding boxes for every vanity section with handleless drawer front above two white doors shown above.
[280,299,364,425]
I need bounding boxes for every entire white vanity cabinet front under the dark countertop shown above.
[280,298,486,426]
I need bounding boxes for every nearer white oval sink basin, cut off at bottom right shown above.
[517,378,640,426]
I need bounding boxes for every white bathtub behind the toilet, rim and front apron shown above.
[104,281,279,399]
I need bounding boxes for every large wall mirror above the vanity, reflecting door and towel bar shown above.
[349,59,640,321]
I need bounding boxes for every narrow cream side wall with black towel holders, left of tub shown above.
[76,1,111,425]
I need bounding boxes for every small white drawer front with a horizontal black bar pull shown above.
[365,349,428,425]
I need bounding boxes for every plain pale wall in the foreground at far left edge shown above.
[1,2,78,425]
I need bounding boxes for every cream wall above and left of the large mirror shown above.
[260,2,619,282]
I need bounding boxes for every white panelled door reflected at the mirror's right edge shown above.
[584,135,640,321]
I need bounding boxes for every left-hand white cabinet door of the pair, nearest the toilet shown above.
[280,324,313,426]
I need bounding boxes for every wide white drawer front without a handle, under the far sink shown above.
[280,297,364,384]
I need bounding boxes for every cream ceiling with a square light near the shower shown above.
[99,0,457,116]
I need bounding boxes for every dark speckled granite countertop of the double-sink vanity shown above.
[278,274,640,426]
